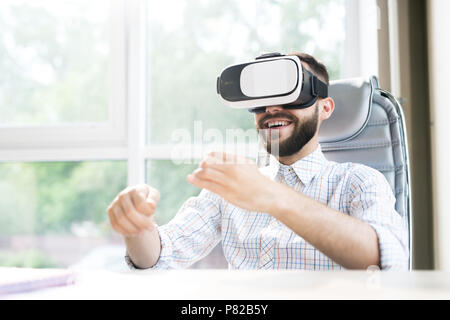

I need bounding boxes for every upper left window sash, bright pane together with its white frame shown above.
[0,0,125,150]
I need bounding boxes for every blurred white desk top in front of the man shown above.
[2,270,450,300]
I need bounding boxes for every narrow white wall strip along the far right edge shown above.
[427,0,450,271]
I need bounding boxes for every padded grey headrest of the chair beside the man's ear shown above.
[319,77,378,143]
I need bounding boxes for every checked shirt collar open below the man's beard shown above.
[267,145,327,186]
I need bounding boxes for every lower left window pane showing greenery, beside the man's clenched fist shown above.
[0,161,126,267]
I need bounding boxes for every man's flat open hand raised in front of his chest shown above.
[187,152,283,212]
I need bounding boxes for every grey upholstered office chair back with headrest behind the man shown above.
[319,77,412,269]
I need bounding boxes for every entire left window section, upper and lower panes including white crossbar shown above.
[0,0,127,267]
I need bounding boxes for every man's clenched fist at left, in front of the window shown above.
[108,185,159,237]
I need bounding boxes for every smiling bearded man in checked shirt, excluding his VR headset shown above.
[108,53,409,270]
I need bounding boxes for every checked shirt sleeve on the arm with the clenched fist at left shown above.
[138,190,222,269]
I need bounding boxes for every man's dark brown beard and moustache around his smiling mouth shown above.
[258,105,319,157]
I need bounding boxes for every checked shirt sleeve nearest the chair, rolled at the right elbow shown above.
[348,166,409,270]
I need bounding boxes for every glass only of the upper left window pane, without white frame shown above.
[0,1,110,126]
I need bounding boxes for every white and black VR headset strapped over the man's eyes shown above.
[217,53,328,113]
